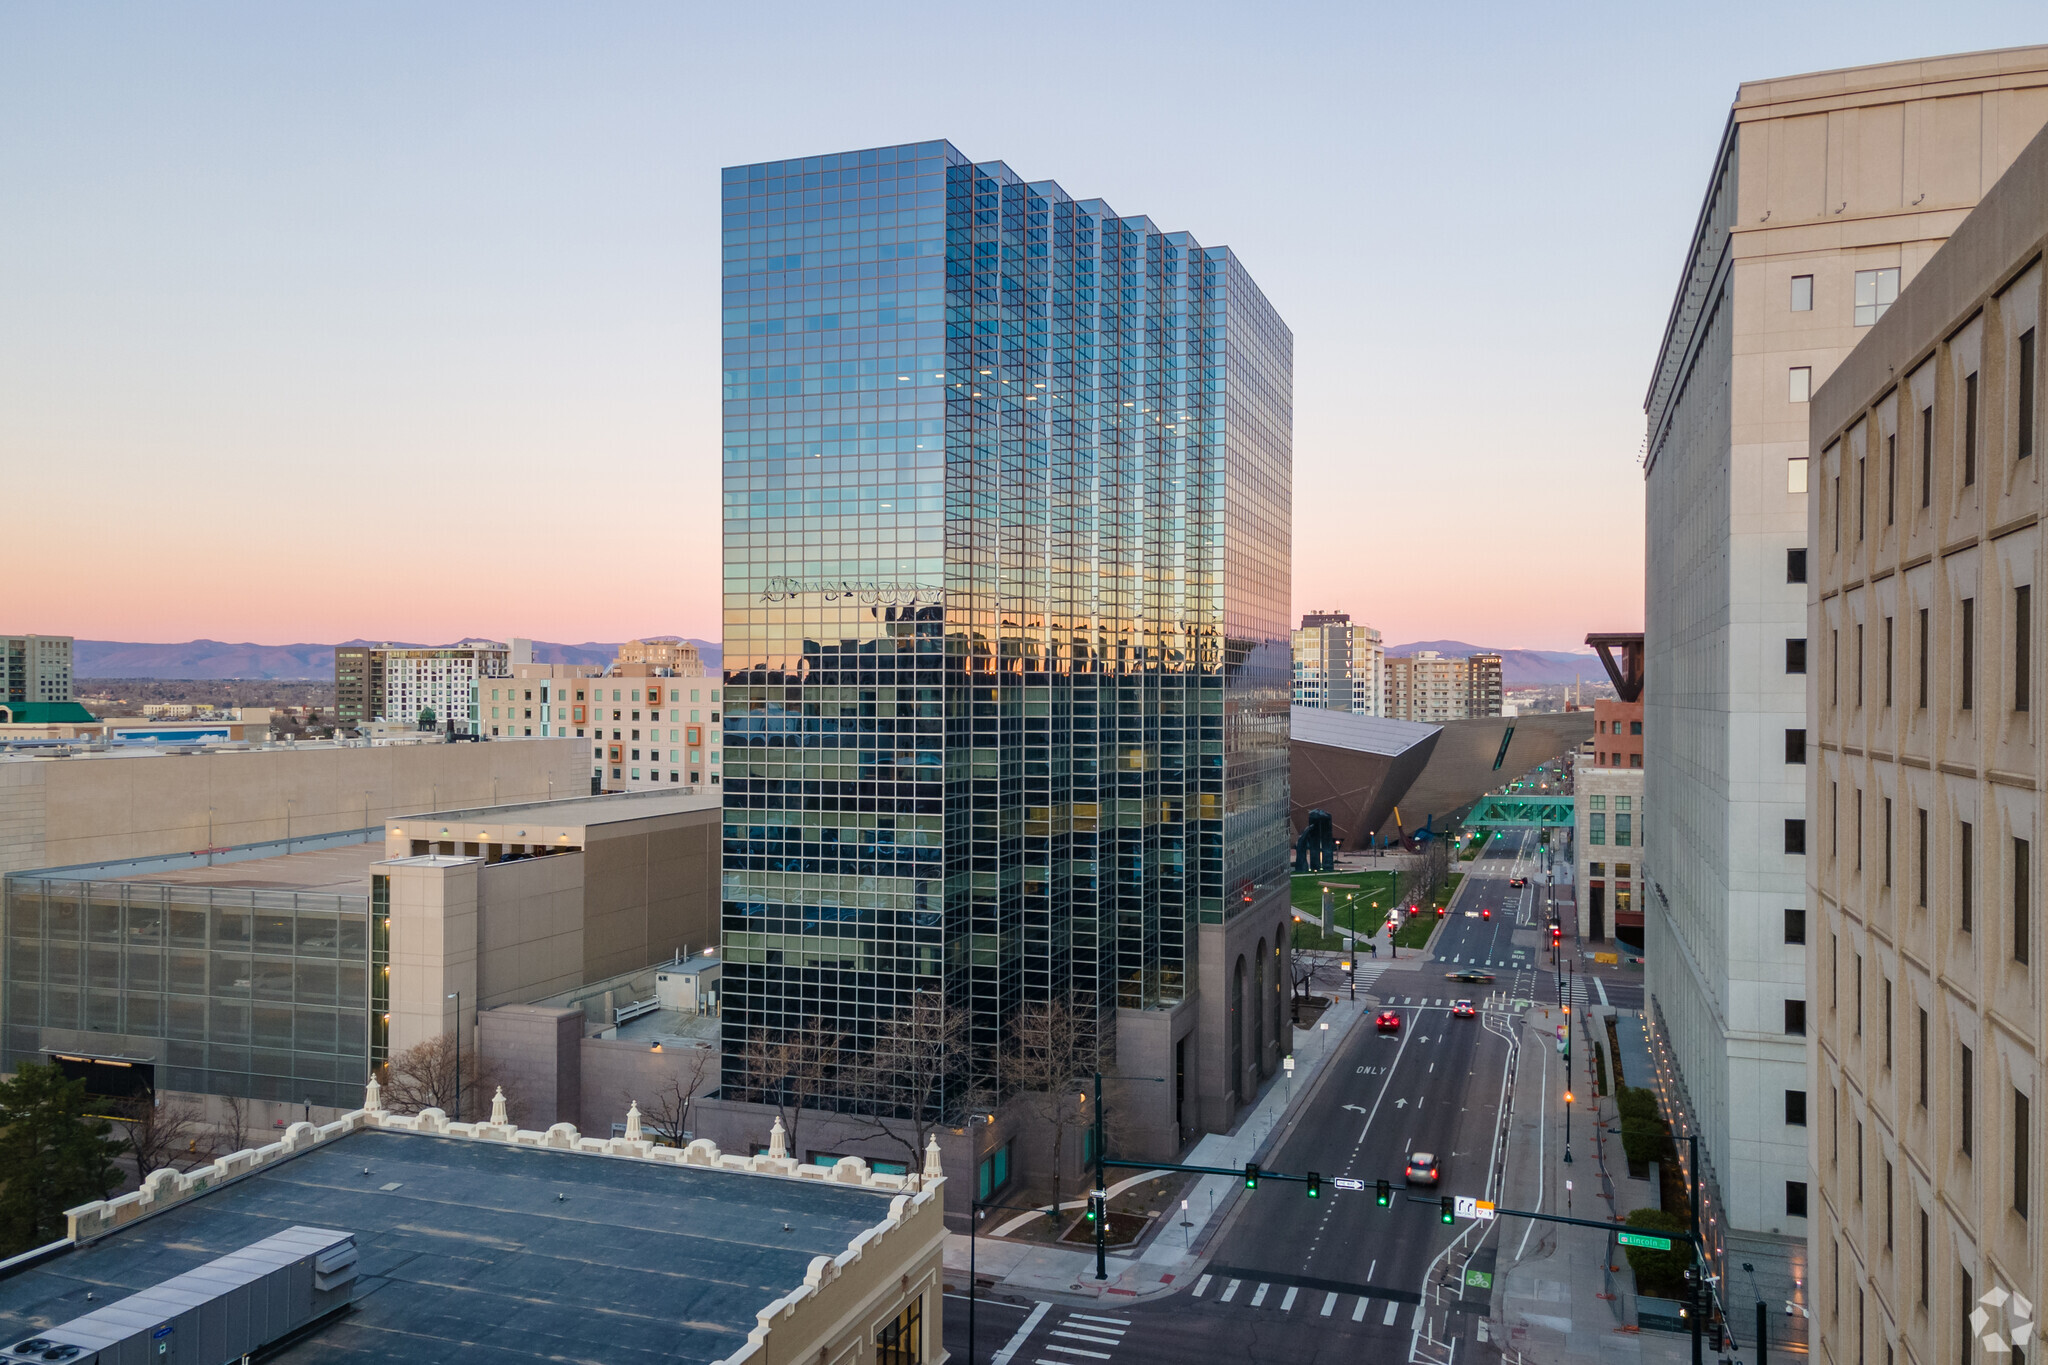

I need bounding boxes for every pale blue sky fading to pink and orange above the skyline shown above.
[0,0,2048,649]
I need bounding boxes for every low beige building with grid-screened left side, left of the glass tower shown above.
[0,789,721,1107]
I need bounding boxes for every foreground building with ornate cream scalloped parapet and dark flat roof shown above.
[0,1091,948,1365]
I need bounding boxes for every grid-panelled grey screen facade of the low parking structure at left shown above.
[4,876,371,1107]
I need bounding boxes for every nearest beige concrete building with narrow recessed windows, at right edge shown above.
[1810,114,2048,1361]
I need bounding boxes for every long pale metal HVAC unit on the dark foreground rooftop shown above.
[0,1228,356,1365]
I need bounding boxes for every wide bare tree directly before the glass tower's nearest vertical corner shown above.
[846,988,985,1171]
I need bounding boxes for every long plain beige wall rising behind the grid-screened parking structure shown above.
[0,739,590,872]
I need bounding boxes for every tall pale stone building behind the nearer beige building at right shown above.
[1642,47,2048,1334]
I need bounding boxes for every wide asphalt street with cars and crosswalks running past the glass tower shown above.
[946,831,1556,1365]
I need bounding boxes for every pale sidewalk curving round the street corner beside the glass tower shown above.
[946,958,1407,1300]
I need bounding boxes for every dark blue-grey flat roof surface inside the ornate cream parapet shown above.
[0,1130,891,1365]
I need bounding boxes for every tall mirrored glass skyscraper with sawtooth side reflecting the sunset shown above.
[723,141,1292,1137]
